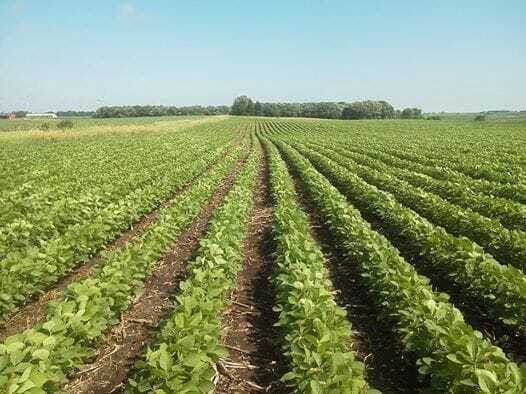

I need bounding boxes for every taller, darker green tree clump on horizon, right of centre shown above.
[230,96,422,119]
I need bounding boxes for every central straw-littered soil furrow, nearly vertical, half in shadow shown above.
[215,149,289,394]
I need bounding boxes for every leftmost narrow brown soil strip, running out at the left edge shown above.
[0,144,237,342]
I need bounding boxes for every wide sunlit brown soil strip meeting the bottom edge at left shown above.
[65,144,249,394]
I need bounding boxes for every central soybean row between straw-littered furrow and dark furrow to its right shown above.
[265,141,374,394]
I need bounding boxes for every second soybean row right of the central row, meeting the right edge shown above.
[293,143,526,331]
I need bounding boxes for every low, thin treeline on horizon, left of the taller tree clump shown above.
[93,105,230,118]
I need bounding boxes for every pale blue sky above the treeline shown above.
[0,0,526,112]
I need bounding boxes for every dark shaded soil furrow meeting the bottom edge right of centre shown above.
[284,155,425,394]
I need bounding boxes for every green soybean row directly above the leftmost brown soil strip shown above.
[0,135,237,321]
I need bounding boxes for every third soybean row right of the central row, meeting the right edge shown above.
[307,142,526,271]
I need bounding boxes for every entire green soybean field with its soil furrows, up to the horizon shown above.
[0,116,526,394]
